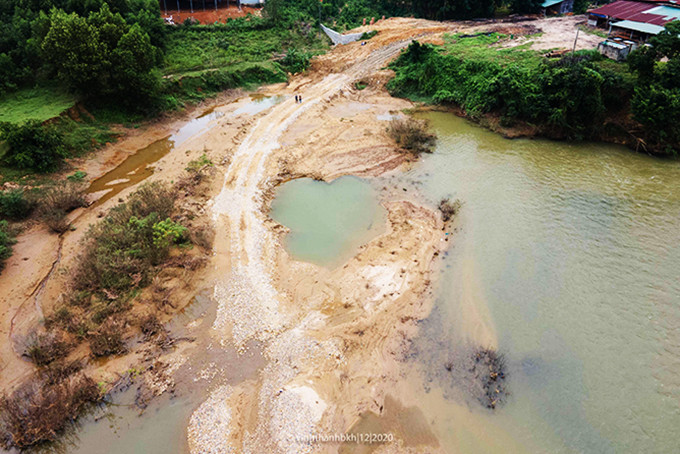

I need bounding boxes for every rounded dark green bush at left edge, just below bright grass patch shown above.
[3,120,67,172]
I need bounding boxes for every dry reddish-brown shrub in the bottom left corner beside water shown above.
[0,374,101,449]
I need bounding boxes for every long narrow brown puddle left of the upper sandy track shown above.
[87,109,224,207]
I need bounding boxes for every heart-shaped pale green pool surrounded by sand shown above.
[271,177,385,268]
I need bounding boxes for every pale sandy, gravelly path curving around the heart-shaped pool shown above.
[188,19,460,453]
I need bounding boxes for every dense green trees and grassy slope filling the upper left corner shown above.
[0,0,326,179]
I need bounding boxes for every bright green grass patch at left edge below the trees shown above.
[0,87,76,124]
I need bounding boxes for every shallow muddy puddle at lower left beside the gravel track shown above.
[31,291,265,454]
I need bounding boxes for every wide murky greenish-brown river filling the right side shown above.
[388,113,680,453]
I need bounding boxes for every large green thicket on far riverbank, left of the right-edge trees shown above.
[388,40,630,139]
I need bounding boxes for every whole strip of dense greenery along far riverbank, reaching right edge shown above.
[388,31,680,153]
